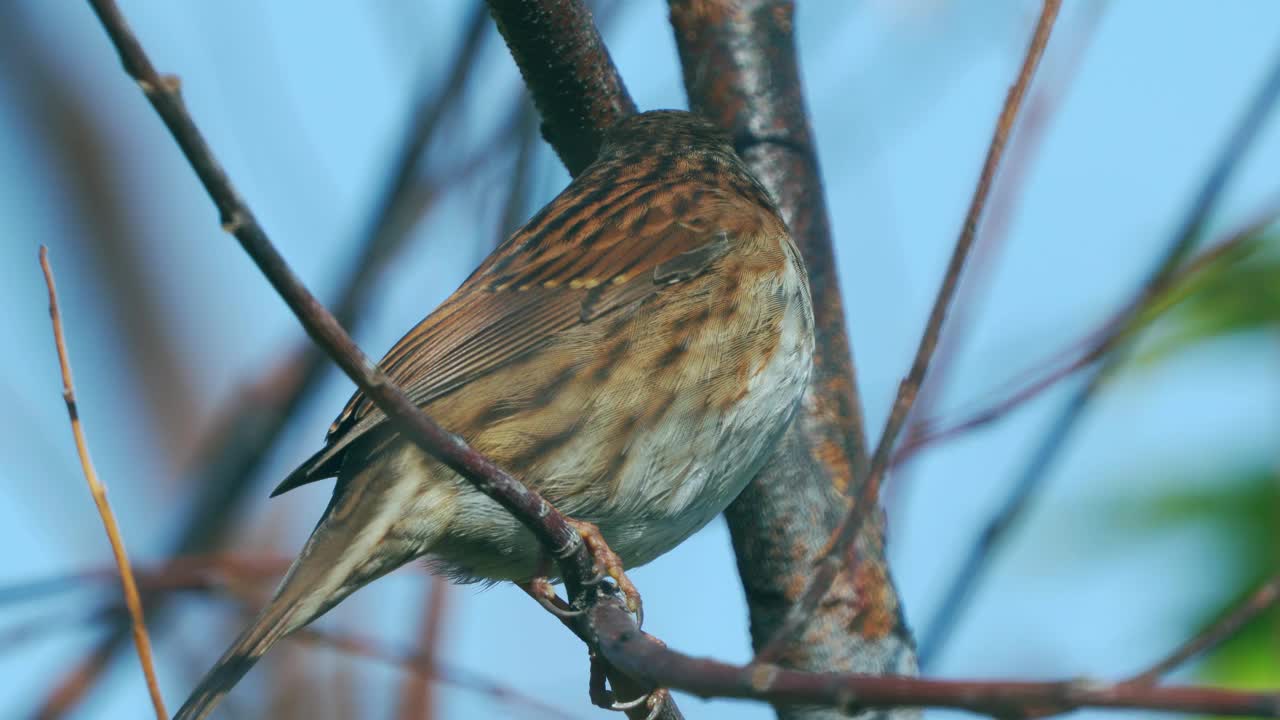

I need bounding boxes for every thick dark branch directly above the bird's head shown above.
[488,0,636,176]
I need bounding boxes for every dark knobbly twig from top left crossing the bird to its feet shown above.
[90,0,596,606]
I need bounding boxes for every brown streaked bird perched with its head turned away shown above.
[177,110,814,720]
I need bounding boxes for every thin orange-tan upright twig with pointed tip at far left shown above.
[40,245,169,720]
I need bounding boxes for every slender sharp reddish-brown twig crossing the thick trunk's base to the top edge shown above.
[756,0,1061,661]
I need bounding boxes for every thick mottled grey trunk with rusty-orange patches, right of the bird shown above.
[669,8,914,719]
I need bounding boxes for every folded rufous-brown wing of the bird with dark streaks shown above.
[271,178,758,496]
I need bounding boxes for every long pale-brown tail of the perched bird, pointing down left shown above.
[174,462,424,720]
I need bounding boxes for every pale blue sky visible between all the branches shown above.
[0,0,1280,719]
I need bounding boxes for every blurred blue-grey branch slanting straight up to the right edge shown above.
[920,44,1280,666]
